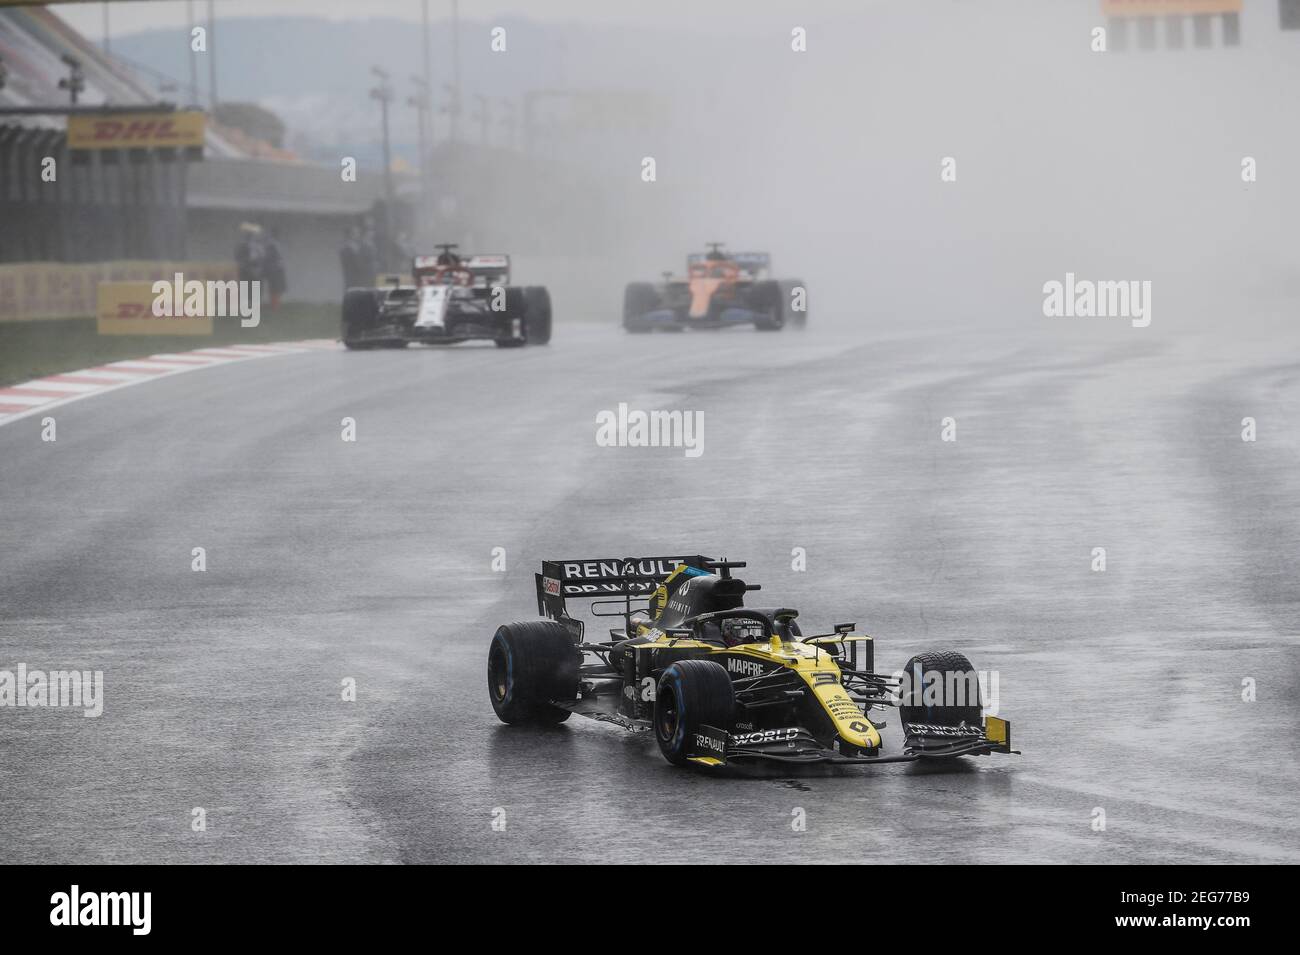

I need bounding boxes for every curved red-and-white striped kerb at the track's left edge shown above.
[0,339,339,426]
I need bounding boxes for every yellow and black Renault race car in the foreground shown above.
[488,555,1014,768]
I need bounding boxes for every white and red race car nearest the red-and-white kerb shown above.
[342,244,551,350]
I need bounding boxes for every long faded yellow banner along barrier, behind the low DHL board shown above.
[0,260,239,322]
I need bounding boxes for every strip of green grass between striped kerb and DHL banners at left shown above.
[0,303,338,386]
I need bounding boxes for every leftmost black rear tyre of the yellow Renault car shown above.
[488,620,582,724]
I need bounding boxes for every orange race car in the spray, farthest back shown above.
[623,242,807,333]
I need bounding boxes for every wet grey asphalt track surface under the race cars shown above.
[0,320,1300,863]
